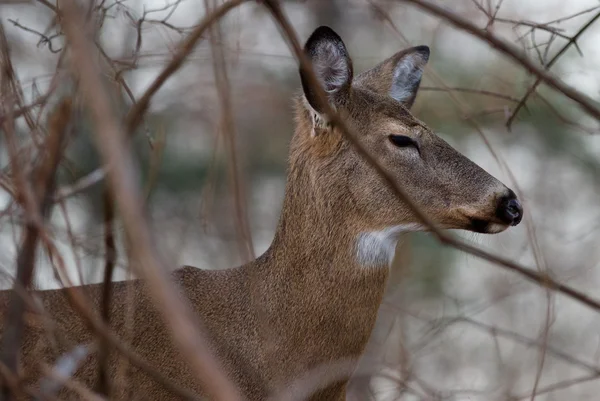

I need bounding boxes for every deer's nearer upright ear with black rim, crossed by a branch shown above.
[300,26,352,113]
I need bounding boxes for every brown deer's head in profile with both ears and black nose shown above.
[288,27,523,268]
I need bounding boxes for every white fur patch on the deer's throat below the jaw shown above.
[356,224,426,267]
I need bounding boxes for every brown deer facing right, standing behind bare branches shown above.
[0,26,523,401]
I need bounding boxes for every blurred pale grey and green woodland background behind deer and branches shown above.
[0,0,600,401]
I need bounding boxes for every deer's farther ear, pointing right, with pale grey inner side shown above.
[356,46,429,108]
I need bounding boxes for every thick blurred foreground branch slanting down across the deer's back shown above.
[61,1,240,400]
